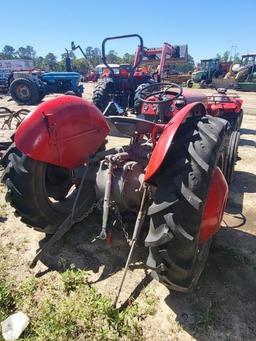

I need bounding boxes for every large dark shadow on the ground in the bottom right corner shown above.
[166,228,256,341]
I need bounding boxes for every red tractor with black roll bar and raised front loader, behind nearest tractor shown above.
[93,34,187,112]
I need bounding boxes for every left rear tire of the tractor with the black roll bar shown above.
[92,79,114,112]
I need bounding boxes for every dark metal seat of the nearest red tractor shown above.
[105,116,162,137]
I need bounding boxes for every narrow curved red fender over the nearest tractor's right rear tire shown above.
[144,102,206,182]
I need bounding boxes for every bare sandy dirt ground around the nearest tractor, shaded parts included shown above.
[0,83,256,341]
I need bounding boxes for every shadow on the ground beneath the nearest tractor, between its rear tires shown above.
[37,213,147,281]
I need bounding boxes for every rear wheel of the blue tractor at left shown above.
[10,78,40,105]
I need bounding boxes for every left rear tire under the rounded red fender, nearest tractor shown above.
[2,153,95,234]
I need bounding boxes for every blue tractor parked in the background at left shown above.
[9,70,84,105]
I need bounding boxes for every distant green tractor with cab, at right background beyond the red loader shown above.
[192,58,232,88]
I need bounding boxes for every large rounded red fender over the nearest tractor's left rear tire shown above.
[15,96,109,169]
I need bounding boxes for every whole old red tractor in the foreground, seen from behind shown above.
[2,83,242,292]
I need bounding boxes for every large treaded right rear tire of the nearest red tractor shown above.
[145,115,228,292]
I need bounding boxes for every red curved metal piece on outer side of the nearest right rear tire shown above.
[199,167,228,244]
